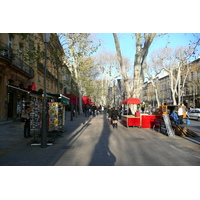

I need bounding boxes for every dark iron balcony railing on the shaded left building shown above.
[0,43,34,78]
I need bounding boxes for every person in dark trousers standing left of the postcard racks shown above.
[21,106,32,138]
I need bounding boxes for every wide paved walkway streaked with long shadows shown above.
[0,112,200,166]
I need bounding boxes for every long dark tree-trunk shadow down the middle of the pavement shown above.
[89,115,116,166]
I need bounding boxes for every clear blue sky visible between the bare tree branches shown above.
[96,33,200,63]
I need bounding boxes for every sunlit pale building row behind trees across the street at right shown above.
[141,58,200,107]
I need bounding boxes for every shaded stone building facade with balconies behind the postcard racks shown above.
[0,33,64,120]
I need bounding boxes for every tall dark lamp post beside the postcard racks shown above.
[41,33,50,148]
